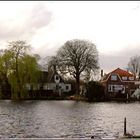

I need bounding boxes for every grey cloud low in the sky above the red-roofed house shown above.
[99,46,140,73]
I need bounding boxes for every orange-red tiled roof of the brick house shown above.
[110,68,134,76]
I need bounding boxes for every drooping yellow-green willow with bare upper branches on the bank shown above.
[0,41,39,100]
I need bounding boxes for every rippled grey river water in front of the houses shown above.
[0,101,140,138]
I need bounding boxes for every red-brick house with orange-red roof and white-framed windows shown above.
[101,68,138,97]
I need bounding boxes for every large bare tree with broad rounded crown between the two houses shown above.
[55,39,99,94]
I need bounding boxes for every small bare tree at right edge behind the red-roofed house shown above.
[127,56,140,79]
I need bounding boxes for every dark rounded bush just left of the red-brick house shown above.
[86,81,105,101]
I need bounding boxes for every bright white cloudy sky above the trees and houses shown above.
[0,1,140,73]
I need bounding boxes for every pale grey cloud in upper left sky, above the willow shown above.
[0,4,52,40]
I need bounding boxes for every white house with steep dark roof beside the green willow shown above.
[26,66,71,96]
